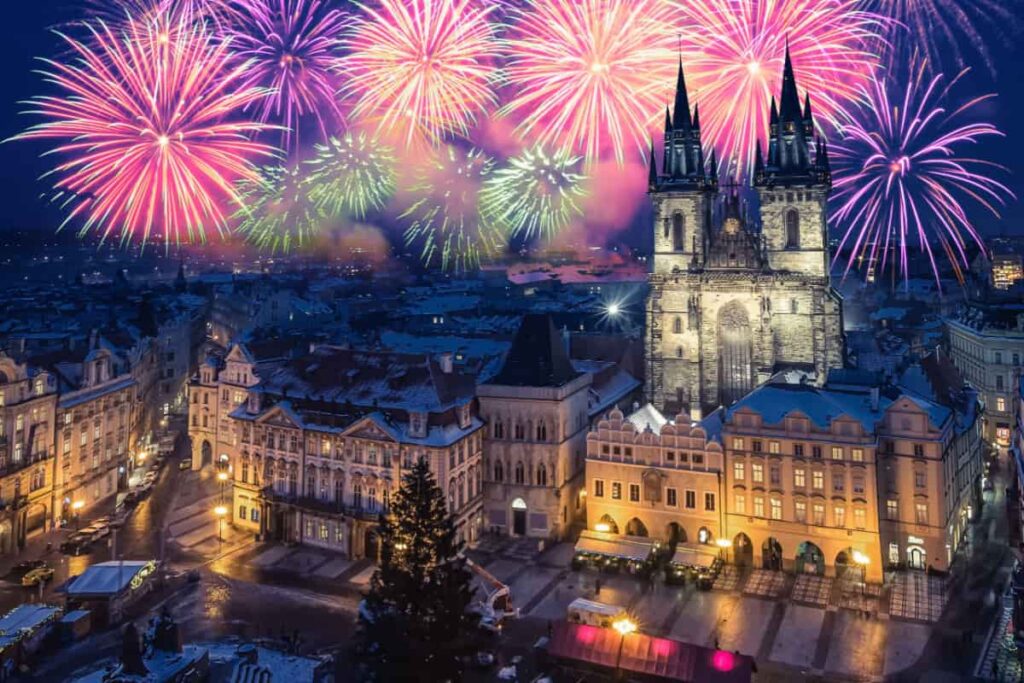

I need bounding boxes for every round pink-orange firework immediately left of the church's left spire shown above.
[502,0,677,164]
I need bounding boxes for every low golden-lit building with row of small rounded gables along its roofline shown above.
[587,403,725,545]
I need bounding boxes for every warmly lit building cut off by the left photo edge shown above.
[0,352,57,553]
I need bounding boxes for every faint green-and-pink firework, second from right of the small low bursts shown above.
[399,145,504,272]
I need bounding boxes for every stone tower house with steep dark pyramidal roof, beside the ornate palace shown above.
[476,314,640,539]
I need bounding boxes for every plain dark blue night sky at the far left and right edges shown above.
[0,0,1024,234]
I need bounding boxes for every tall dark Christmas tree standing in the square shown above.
[358,459,472,683]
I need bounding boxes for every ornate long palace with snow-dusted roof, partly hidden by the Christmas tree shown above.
[189,344,483,558]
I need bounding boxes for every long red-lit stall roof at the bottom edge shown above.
[548,622,753,683]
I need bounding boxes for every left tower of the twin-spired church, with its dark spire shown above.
[648,61,718,272]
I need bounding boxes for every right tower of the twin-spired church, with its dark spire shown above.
[754,47,831,276]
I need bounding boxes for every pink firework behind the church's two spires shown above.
[676,0,886,177]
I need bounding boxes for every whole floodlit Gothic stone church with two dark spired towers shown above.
[645,52,843,419]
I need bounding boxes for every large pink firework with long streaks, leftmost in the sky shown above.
[16,17,273,244]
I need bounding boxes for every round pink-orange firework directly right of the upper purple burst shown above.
[339,0,498,147]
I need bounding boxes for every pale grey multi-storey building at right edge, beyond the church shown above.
[946,306,1024,447]
